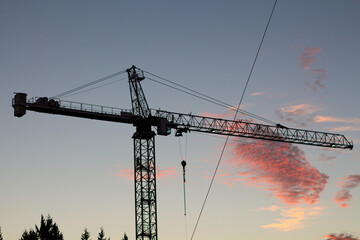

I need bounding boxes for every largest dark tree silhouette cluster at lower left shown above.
[20,215,64,240]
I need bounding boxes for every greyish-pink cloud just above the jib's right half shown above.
[275,104,321,127]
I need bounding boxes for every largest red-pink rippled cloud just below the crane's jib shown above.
[225,139,328,205]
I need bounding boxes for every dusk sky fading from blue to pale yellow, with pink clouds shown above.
[0,0,360,240]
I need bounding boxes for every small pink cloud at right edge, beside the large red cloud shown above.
[333,175,360,208]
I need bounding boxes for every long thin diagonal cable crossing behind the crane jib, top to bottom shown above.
[190,0,277,240]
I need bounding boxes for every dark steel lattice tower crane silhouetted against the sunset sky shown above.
[12,66,353,240]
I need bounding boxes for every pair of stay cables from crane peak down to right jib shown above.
[144,76,276,125]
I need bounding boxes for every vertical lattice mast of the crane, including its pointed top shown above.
[127,66,157,240]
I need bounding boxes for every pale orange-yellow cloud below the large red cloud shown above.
[261,207,322,232]
